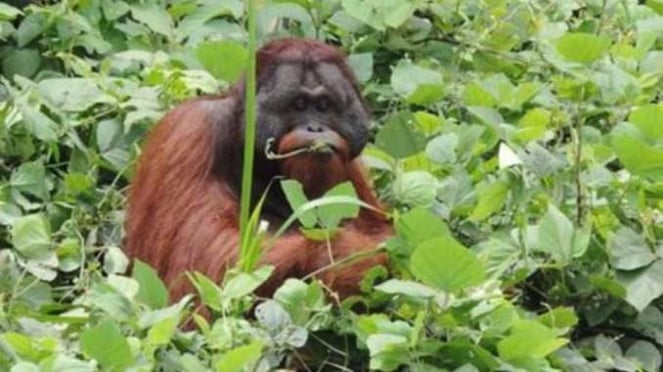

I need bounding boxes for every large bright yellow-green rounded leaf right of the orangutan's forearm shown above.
[410,236,485,293]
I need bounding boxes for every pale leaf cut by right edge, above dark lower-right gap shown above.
[617,259,663,311]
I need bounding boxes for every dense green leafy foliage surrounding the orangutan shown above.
[0,0,663,372]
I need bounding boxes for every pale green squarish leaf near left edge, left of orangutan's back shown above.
[11,214,51,259]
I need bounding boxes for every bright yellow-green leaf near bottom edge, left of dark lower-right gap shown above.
[497,320,568,366]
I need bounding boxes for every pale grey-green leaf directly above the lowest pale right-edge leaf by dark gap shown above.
[609,227,656,270]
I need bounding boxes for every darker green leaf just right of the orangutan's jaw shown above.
[375,112,426,159]
